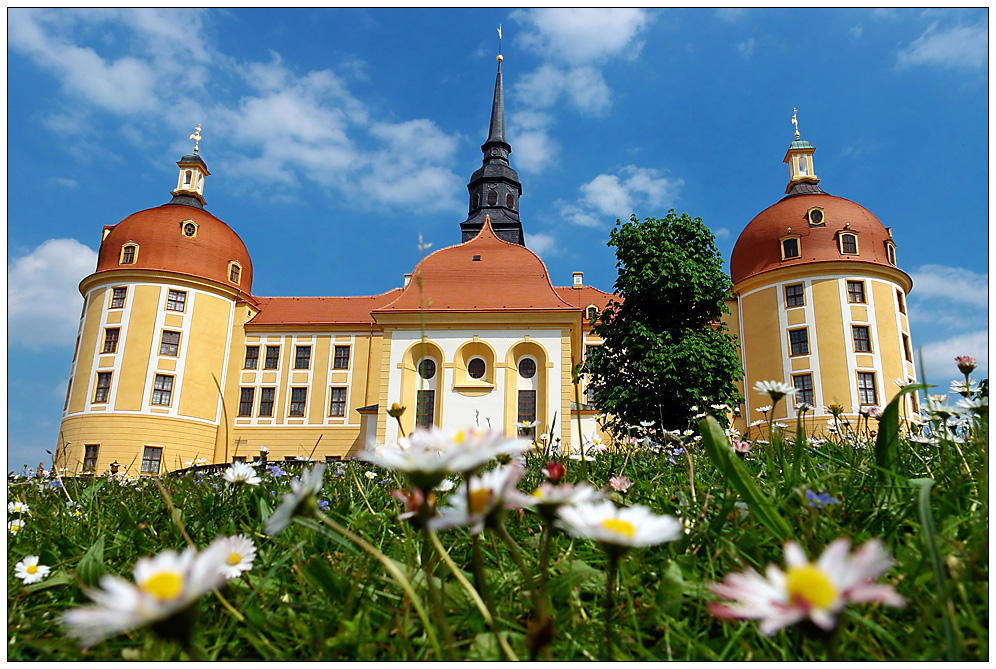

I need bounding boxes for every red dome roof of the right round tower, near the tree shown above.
[730,193,894,284]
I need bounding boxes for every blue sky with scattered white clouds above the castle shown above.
[7,9,989,469]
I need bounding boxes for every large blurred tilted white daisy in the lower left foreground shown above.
[62,544,231,646]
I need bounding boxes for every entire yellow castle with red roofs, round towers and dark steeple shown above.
[56,57,918,474]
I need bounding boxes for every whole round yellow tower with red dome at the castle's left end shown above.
[57,127,254,474]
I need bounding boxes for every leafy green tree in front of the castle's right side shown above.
[583,210,743,430]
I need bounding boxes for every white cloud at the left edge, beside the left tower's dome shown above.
[7,239,97,350]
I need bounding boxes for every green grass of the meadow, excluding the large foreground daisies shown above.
[7,378,989,661]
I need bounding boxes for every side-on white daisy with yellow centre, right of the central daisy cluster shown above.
[557,501,682,555]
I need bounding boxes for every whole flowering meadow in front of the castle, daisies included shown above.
[7,374,989,661]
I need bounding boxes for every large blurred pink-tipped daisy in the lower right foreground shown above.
[709,538,905,636]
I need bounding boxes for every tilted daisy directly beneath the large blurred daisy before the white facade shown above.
[429,463,525,534]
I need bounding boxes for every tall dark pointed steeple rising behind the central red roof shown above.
[460,27,525,246]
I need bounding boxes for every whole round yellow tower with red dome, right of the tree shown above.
[730,114,919,434]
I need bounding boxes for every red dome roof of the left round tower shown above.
[97,204,252,293]
